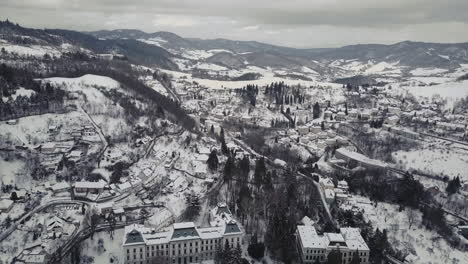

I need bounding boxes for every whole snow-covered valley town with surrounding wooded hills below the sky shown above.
[0,1,468,264]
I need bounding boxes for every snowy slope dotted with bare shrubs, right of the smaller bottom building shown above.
[342,196,468,264]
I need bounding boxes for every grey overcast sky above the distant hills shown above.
[0,0,468,48]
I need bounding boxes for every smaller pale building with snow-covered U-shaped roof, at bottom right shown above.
[296,225,369,264]
